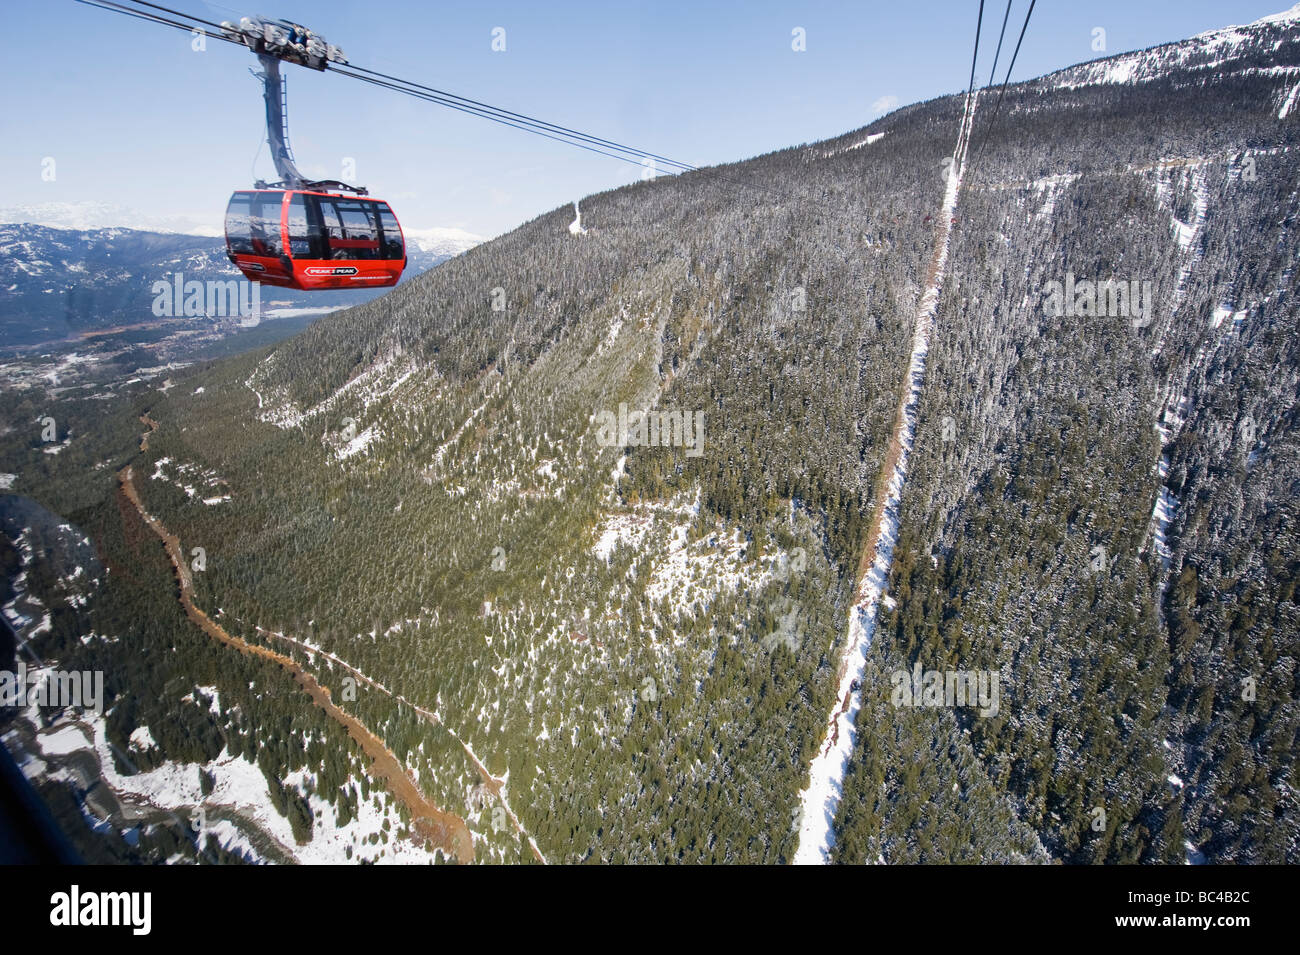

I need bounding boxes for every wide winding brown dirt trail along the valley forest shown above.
[118,414,475,863]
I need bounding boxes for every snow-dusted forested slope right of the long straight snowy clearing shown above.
[840,7,1300,861]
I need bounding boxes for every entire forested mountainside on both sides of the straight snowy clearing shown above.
[5,5,1300,863]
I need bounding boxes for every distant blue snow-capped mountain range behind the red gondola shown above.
[0,214,481,347]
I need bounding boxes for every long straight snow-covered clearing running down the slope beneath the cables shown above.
[793,91,979,865]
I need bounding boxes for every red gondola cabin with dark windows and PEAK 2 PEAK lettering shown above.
[226,190,406,291]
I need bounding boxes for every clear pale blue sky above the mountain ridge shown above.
[0,0,1291,236]
